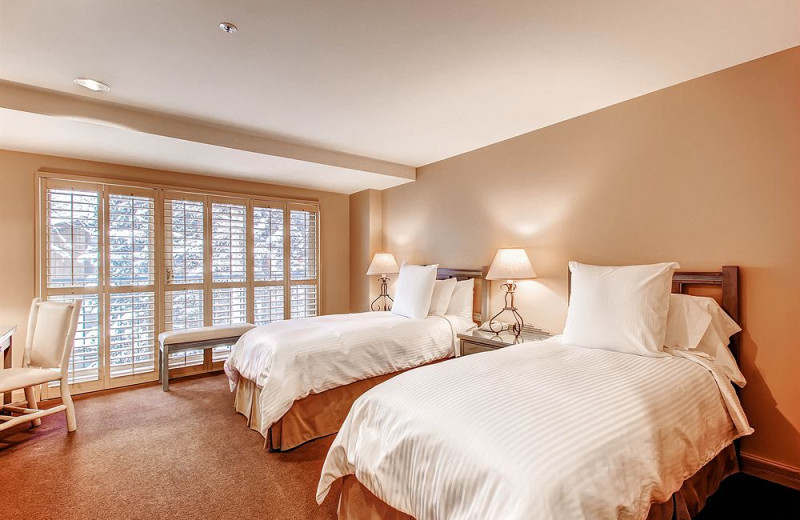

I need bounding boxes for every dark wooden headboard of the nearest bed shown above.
[567,265,742,362]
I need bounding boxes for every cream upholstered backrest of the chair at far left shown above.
[23,298,81,374]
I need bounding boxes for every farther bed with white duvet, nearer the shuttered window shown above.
[220,264,486,451]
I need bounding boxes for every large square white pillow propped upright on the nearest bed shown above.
[563,262,680,356]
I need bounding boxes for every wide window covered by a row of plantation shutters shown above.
[39,174,319,397]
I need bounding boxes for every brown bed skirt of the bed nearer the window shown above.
[233,372,398,451]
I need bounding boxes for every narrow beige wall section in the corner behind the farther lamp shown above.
[350,190,382,312]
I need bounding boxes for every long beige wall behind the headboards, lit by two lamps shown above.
[383,48,800,468]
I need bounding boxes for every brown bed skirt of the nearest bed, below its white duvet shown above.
[339,445,739,520]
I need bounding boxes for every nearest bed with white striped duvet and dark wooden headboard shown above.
[317,262,753,520]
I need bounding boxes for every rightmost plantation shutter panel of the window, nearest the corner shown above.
[289,205,319,318]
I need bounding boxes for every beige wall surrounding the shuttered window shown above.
[0,150,350,363]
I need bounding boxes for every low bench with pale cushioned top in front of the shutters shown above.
[158,323,255,392]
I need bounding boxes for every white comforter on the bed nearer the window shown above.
[225,312,474,436]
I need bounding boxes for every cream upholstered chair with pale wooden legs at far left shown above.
[0,298,81,432]
